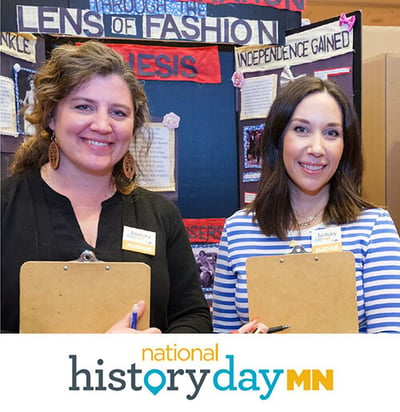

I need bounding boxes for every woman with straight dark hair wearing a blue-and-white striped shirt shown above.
[213,77,400,333]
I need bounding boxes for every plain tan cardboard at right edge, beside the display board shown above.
[362,53,400,231]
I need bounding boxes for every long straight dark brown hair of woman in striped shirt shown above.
[247,77,374,239]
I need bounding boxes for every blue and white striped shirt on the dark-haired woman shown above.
[213,208,400,333]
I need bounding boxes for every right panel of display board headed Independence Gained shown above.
[235,11,362,206]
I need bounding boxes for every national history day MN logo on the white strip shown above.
[68,343,334,400]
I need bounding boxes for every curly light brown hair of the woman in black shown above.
[10,40,150,194]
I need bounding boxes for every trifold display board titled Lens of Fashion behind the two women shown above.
[1,0,361,218]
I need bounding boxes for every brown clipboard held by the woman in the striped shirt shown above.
[246,252,358,333]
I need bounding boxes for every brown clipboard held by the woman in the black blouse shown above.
[20,261,150,333]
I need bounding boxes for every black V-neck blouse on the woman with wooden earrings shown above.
[1,171,212,333]
